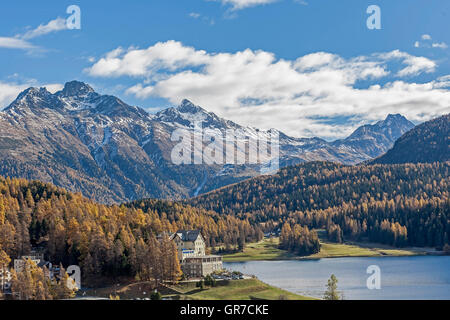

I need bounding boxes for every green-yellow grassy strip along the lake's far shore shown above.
[223,238,439,262]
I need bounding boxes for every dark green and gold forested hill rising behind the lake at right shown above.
[188,162,450,247]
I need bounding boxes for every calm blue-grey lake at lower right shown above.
[224,256,450,300]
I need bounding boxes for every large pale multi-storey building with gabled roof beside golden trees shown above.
[170,230,222,278]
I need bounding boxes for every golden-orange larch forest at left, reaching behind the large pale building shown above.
[0,177,263,279]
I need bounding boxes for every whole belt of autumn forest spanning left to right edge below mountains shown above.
[0,162,450,279]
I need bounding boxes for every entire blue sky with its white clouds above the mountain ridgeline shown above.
[0,0,450,138]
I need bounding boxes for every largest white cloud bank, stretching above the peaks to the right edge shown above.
[85,41,450,138]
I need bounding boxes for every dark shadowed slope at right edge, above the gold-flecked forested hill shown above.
[372,114,450,164]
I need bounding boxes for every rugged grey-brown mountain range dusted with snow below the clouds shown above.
[0,81,414,203]
